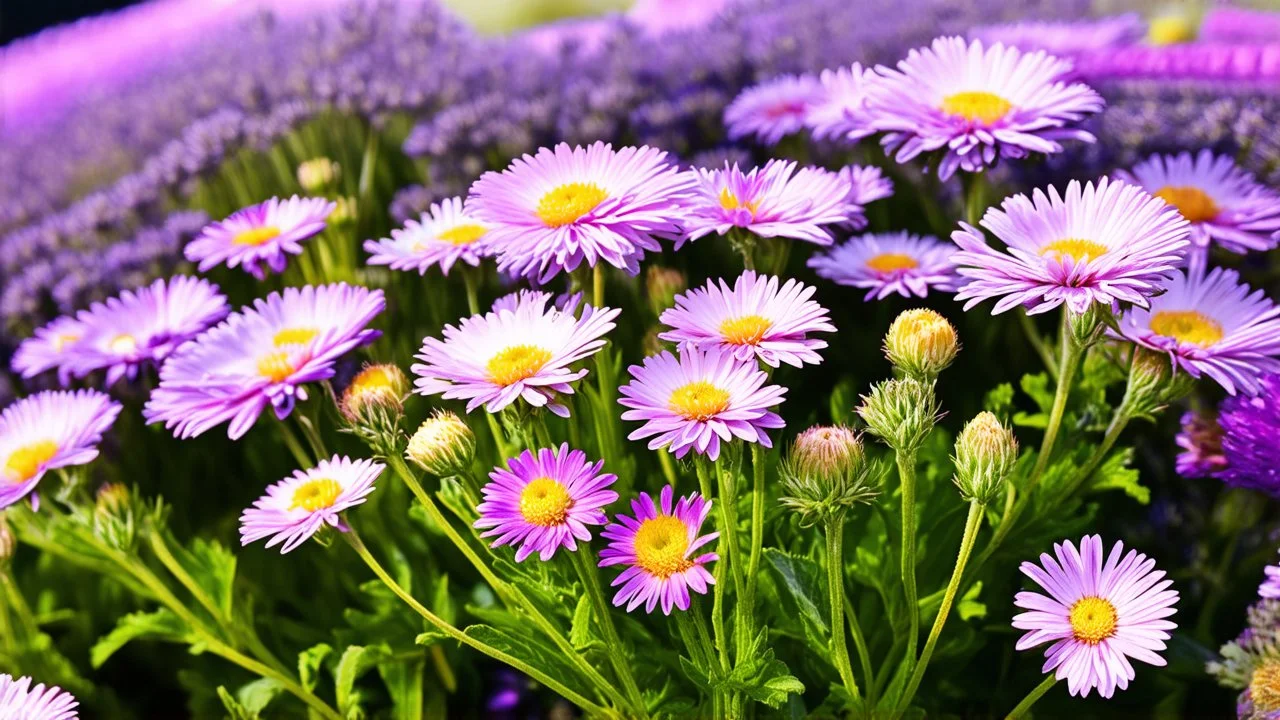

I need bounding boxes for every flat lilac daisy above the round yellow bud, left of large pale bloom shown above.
[809,232,960,300]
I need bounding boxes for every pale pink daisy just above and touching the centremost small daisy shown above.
[658,270,836,368]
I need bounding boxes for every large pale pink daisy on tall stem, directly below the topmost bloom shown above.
[951,178,1188,314]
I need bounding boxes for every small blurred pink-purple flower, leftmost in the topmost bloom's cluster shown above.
[724,76,828,145]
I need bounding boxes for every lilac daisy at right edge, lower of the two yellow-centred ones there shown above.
[1119,268,1280,395]
